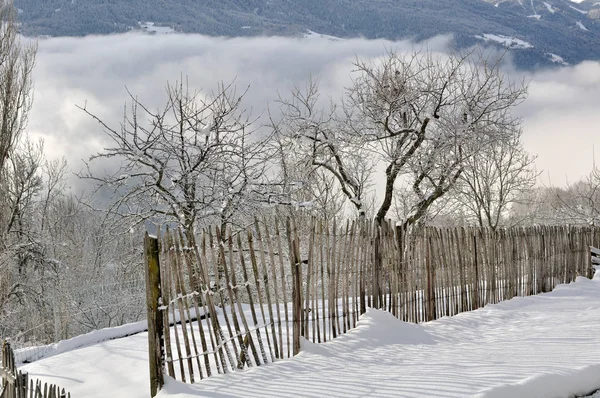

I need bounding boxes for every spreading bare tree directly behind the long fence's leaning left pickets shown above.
[80,78,274,238]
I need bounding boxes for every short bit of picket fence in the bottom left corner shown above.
[0,341,71,398]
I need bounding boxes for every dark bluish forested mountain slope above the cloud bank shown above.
[15,0,600,67]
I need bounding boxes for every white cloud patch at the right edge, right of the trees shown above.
[517,62,600,185]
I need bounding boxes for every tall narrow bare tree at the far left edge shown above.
[0,0,39,310]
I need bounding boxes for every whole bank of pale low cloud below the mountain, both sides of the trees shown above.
[29,34,600,189]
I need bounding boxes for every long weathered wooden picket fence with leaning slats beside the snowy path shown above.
[145,219,600,396]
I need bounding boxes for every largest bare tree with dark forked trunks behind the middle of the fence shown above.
[276,51,526,225]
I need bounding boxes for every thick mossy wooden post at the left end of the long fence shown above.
[144,232,165,397]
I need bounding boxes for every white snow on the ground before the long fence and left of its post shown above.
[23,273,600,398]
